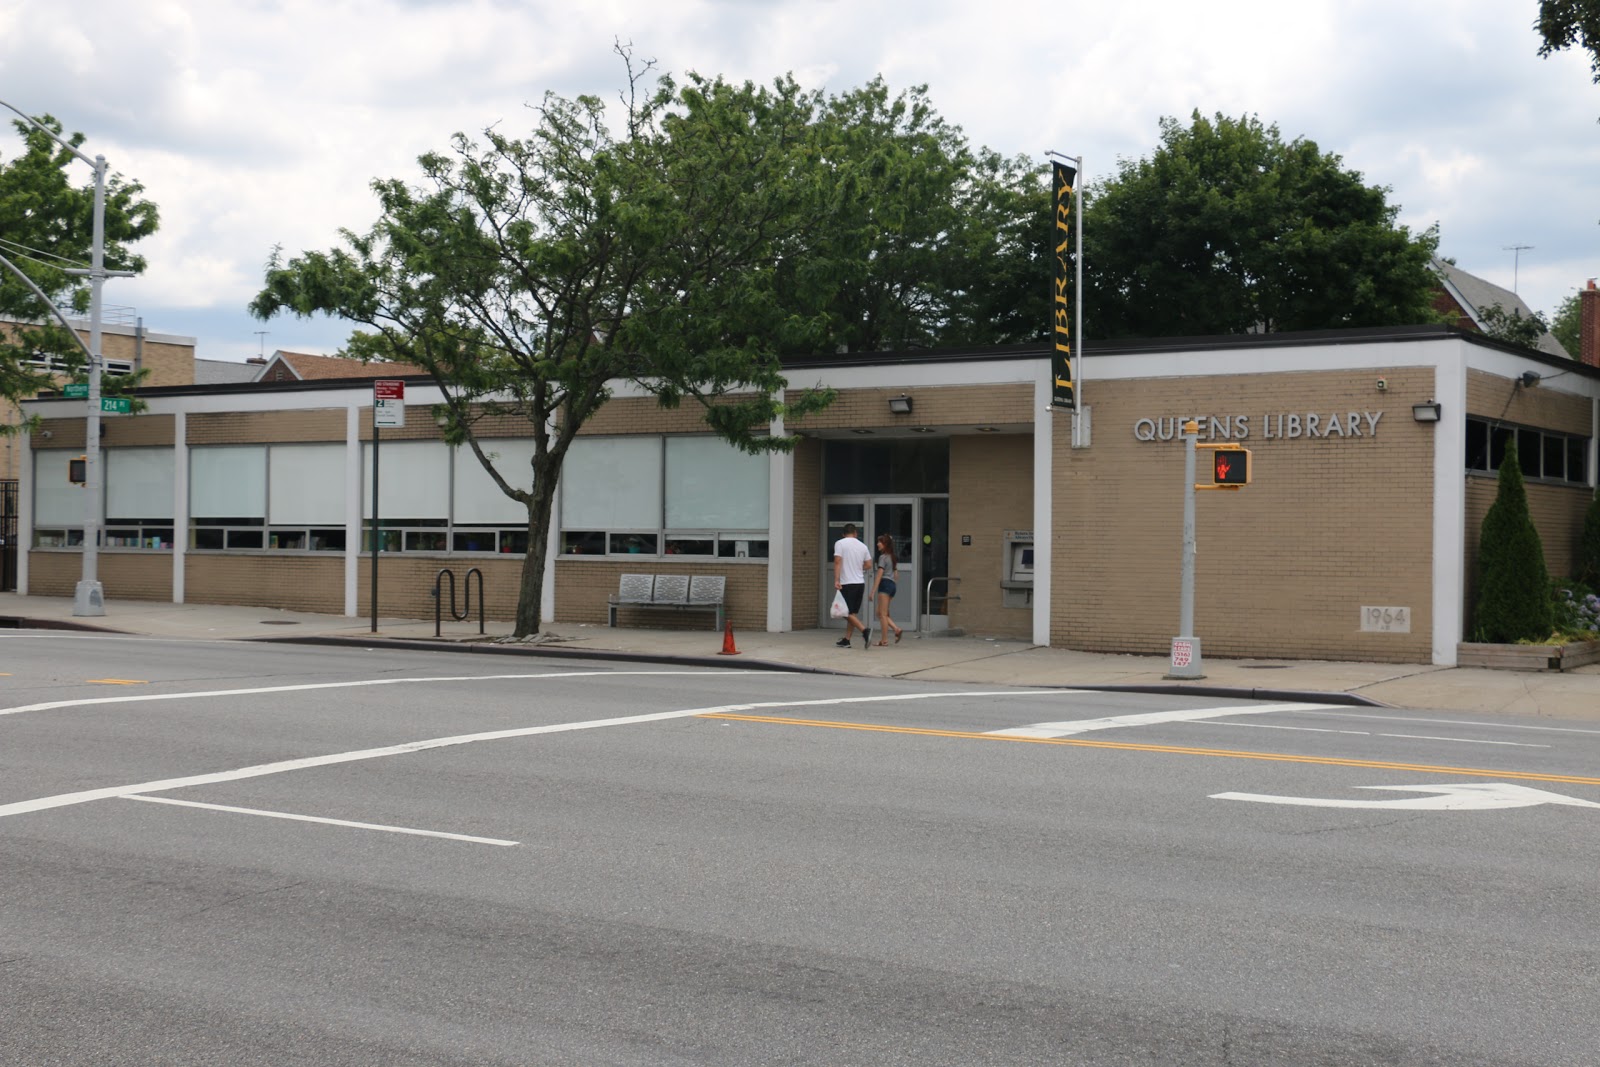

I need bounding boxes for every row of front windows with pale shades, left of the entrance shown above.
[34,437,770,558]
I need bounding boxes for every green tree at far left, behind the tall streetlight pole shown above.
[0,115,160,409]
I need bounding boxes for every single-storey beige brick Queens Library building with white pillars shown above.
[18,310,1600,665]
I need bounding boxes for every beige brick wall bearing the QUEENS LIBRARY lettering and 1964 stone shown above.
[1051,368,1434,662]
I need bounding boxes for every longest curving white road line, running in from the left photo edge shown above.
[0,687,1075,819]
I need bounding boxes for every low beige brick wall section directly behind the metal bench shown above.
[555,558,766,630]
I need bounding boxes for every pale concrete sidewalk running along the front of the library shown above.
[0,593,1600,720]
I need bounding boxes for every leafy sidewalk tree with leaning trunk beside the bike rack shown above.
[251,58,853,637]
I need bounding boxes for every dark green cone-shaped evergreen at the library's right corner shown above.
[1474,440,1554,643]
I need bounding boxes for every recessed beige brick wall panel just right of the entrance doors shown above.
[947,435,1034,638]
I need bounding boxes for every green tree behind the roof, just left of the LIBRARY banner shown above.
[782,78,1050,352]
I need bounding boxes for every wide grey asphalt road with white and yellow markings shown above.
[0,632,1600,1067]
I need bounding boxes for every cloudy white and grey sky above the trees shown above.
[0,0,1600,360]
